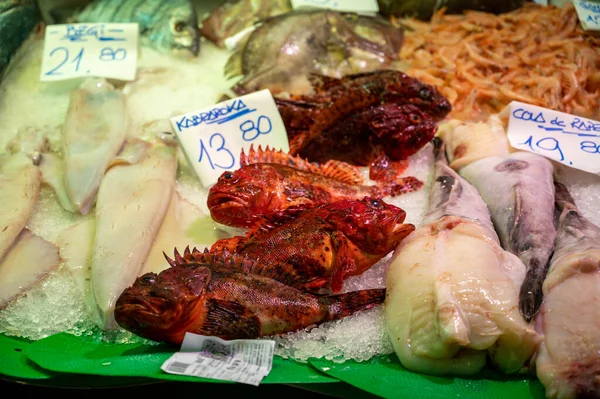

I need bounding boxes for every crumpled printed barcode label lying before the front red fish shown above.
[161,333,275,386]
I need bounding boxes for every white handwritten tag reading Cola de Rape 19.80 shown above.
[500,101,600,173]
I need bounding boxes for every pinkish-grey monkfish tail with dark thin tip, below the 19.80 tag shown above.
[460,151,556,321]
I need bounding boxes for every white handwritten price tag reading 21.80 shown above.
[40,23,138,81]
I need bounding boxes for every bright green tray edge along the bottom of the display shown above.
[0,333,545,399]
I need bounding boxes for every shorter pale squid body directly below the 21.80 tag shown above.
[62,79,127,215]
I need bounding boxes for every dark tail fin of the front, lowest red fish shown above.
[319,288,386,320]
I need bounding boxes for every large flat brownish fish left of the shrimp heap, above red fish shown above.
[225,10,404,93]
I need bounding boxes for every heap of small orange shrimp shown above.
[401,2,600,120]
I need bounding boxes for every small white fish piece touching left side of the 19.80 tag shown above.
[437,115,511,172]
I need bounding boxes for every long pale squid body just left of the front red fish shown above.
[91,145,177,330]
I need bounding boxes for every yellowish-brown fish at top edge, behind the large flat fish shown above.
[200,0,292,47]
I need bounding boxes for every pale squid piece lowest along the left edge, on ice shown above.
[0,229,60,309]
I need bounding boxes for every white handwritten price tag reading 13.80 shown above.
[170,89,290,188]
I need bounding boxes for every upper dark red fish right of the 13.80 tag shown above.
[277,70,451,155]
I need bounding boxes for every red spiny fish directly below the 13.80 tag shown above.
[207,147,423,227]
